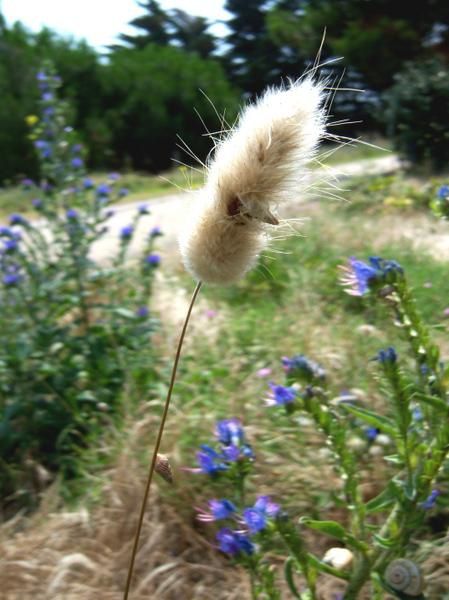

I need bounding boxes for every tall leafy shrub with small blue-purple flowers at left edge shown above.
[0,67,160,506]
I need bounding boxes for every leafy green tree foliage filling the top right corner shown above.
[294,0,449,91]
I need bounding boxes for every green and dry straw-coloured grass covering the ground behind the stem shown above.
[0,158,449,600]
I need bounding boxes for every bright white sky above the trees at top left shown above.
[0,0,227,51]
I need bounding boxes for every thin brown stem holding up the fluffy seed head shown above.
[123,281,202,600]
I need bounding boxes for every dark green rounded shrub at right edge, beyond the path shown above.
[384,59,449,170]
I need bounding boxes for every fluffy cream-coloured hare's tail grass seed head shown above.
[180,77,325,284]
